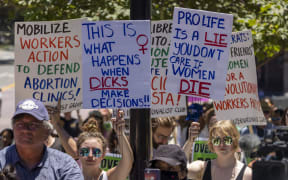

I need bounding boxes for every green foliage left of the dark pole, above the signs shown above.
[4,0,129,21]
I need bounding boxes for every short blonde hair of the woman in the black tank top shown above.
[208,120,240,152]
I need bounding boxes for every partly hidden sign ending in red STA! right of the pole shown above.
[151,20,187,117]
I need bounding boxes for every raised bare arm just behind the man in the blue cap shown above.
[47,101,78,159]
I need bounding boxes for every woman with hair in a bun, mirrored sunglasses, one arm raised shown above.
[77,109,134,180]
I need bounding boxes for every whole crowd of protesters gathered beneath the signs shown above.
[0,95,288,180]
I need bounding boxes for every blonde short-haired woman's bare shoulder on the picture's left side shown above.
[187,160,206,179]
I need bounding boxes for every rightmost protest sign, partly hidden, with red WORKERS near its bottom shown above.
[213,31,266,126]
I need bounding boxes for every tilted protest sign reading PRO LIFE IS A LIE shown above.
[166,8,233,100]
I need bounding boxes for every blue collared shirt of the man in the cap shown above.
[0,145,84,180]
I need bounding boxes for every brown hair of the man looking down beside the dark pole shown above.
[151,117,176,132]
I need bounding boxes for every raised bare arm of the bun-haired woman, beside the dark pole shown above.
[107,112,134,180]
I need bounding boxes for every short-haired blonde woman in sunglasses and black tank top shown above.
[188,120,252,180]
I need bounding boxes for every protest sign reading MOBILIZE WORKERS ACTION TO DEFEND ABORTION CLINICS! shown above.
[15,19,82,112]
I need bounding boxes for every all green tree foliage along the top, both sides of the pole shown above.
[0,0,288,63]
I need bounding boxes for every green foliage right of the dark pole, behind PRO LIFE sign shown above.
[152,0,288,64]
